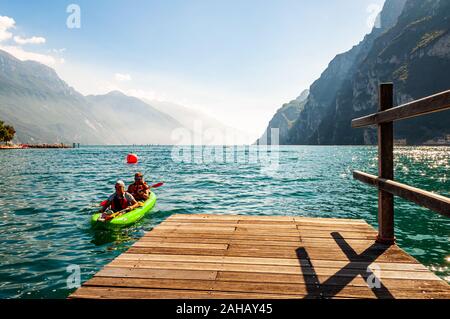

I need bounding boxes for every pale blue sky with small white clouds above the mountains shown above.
[0,0,384,140]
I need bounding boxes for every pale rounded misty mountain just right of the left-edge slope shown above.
[86,91,183,144]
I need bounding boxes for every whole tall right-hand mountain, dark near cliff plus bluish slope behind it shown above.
[264,0,450,145]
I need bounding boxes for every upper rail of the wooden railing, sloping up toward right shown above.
[352,90,450,128]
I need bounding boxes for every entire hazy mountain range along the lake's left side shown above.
[0,50,232,145]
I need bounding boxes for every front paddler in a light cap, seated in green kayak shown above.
[99,181,141,221]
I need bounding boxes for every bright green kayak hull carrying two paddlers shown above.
[91,192,156,229]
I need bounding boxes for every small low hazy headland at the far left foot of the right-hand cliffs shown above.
[256,90,309,145]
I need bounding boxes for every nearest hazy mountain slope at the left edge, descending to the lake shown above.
[0,50,117,144]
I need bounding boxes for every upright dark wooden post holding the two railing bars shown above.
[377,83,395,245]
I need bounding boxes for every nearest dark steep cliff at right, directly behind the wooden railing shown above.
[316,0,450,144]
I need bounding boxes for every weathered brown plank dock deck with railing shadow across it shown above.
[70,215,450,299]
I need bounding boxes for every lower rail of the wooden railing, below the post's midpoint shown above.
[353,171,450,217]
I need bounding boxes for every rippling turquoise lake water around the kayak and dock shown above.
[0,146,450,298]
